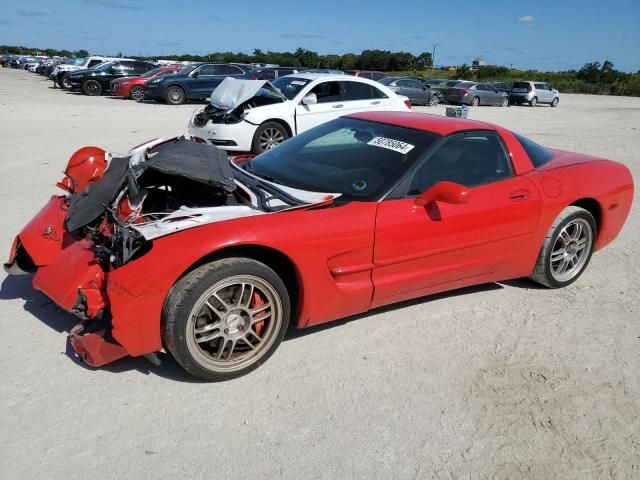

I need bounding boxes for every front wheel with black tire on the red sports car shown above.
[162,258,290,381]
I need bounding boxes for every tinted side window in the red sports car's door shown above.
[407,132,513,196]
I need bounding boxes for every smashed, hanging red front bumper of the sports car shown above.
[4,196,164,367]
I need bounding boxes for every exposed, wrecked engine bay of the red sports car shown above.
[58,137,332,270]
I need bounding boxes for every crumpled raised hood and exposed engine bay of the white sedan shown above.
[193,77,287,127]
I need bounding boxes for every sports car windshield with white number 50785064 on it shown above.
[245,117,439,201]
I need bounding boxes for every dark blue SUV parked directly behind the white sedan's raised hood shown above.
[144,63,251,105]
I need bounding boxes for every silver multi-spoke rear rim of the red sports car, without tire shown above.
[549,218,593,282]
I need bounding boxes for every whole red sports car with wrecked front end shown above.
[5,112,633,380]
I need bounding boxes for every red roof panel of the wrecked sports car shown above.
[348,111,496,135]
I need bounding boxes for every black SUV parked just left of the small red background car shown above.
[67,60,156,96]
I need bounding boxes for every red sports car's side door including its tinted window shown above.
[372,131,540,307]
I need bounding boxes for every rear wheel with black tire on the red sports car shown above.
[530,206,597,288]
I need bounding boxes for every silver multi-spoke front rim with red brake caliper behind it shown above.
[186,275,283,373]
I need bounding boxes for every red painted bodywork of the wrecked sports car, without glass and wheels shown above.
[10,112,633,365]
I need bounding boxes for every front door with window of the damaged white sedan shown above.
[296,80,345,133]
